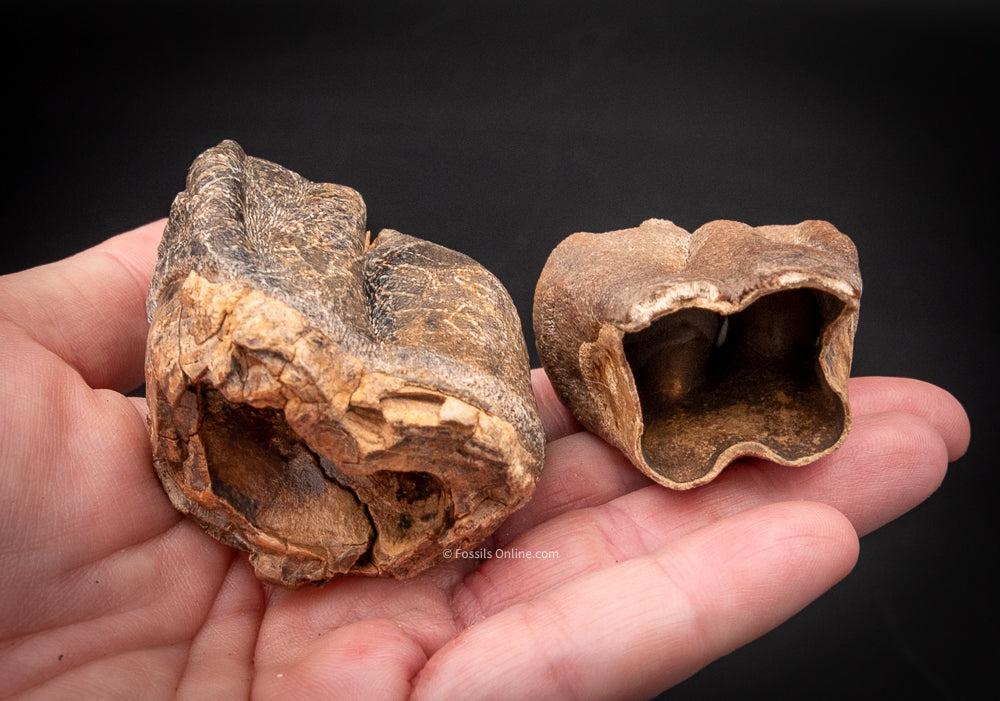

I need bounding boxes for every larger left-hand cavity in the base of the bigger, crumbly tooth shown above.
[189,387,372,547]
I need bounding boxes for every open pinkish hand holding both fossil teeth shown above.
[0,222,969,699]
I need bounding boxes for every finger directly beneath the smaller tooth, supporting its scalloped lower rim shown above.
[454,414,947,615]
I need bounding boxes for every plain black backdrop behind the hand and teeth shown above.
[0,0,1000,699]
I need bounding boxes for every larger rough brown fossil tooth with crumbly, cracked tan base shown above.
[146,141,544,587]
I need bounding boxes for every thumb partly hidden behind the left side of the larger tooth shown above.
[0,221,164,392]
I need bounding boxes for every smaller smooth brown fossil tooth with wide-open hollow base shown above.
[534,219,861,489]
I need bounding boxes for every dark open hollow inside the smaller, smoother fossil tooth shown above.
[624,289,845,483]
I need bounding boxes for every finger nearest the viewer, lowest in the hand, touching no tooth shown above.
[414,502,857,699]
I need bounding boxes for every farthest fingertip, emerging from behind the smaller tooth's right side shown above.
[850,377,970,462]
